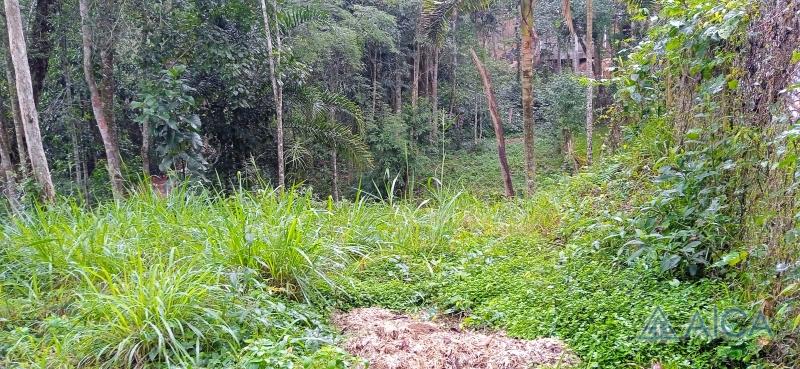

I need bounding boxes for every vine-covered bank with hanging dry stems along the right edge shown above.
[606,0,800,367]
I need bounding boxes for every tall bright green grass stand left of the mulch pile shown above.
[0,189,381,368]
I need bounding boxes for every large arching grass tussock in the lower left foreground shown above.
[76,254,231,368]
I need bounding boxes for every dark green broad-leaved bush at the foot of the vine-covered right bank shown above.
[612,125,752,277]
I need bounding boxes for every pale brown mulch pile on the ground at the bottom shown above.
[333,308,577,369]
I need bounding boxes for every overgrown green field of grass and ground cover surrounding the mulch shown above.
[0,142,768,368]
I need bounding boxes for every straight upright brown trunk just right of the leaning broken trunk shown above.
[520,0,536,195]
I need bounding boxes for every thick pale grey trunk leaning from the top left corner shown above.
[5,0,56,202]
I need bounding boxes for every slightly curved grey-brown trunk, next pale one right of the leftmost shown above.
[79,0,125,200]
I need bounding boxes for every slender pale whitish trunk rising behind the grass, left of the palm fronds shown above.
[261,0,286,188]
